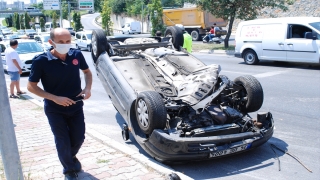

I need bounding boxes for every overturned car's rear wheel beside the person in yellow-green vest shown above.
[164,26,183,50]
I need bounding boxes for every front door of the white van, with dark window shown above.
[285,24,319,62]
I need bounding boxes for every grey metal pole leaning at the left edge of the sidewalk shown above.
[0,46,24,180]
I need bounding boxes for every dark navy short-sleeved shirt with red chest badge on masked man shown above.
[29,49,89,105]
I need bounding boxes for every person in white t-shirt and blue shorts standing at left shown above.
[4,39,26,98]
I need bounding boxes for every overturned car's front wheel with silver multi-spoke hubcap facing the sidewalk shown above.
[135,91,167,134]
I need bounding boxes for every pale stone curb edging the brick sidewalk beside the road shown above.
[21,94,192,180]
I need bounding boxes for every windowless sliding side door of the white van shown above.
[260,23,287,61]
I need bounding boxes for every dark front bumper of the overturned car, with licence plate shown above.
[143,124,274,163]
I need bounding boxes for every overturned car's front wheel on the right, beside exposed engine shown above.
[234,75,263,112]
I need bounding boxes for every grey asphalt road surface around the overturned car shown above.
[6,14,320,180]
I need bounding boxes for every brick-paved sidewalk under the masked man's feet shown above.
[0,95,190,180]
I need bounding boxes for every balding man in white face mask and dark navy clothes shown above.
[28,28,92,180]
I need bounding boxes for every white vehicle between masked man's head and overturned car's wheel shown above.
[75,30,92,51]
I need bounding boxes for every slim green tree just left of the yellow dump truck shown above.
[148,0,165,36]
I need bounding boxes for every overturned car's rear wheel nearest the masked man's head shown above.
[91,29,109,63]
